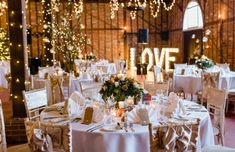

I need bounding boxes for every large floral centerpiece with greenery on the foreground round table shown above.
[100,76,144,102]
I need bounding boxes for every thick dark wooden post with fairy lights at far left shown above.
[8,0,28,118]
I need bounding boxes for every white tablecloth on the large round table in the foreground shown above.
[41,101,214,152]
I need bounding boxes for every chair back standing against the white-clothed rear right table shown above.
[201,72,220,98]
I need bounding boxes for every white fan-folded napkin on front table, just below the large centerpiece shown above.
[127,104,157,123]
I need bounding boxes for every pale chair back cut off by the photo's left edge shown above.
[0,100,7,152]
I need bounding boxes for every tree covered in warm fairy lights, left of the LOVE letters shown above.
[52,0,85,71]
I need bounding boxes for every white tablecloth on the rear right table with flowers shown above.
[174,72,235,94]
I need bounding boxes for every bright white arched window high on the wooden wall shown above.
[183,1,203,31]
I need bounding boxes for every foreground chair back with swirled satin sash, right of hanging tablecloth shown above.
[148,119,200,152]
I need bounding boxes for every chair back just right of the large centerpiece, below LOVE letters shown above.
[144,80,169,95]
